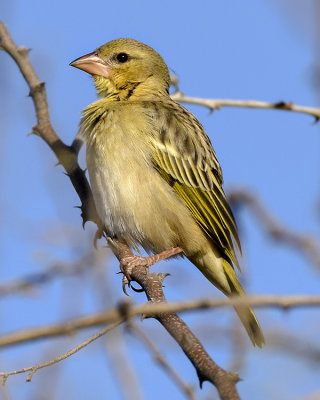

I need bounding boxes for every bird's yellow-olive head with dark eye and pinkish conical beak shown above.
[70,38,170,100]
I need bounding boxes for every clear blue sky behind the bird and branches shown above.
[0,0,320,400]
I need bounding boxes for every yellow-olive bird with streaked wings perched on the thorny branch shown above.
[70,38,265,347]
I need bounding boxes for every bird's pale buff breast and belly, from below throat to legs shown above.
[87,111,186,252]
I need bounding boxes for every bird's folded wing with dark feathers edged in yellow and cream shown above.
[152,102,241,266]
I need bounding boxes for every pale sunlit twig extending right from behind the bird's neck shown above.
[171,92,320,122]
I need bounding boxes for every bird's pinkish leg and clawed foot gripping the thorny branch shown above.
[120,247,183,296]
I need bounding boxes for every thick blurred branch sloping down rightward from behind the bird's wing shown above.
[229,189,320,269]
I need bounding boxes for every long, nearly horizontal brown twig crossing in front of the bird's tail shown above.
[0,294,320,347]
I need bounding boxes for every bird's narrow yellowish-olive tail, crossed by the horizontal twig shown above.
[222,259,265,347]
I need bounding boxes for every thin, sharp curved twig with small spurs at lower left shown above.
[0,320,123,385]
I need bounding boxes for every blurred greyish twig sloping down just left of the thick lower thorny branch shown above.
[128,321,196,400]
